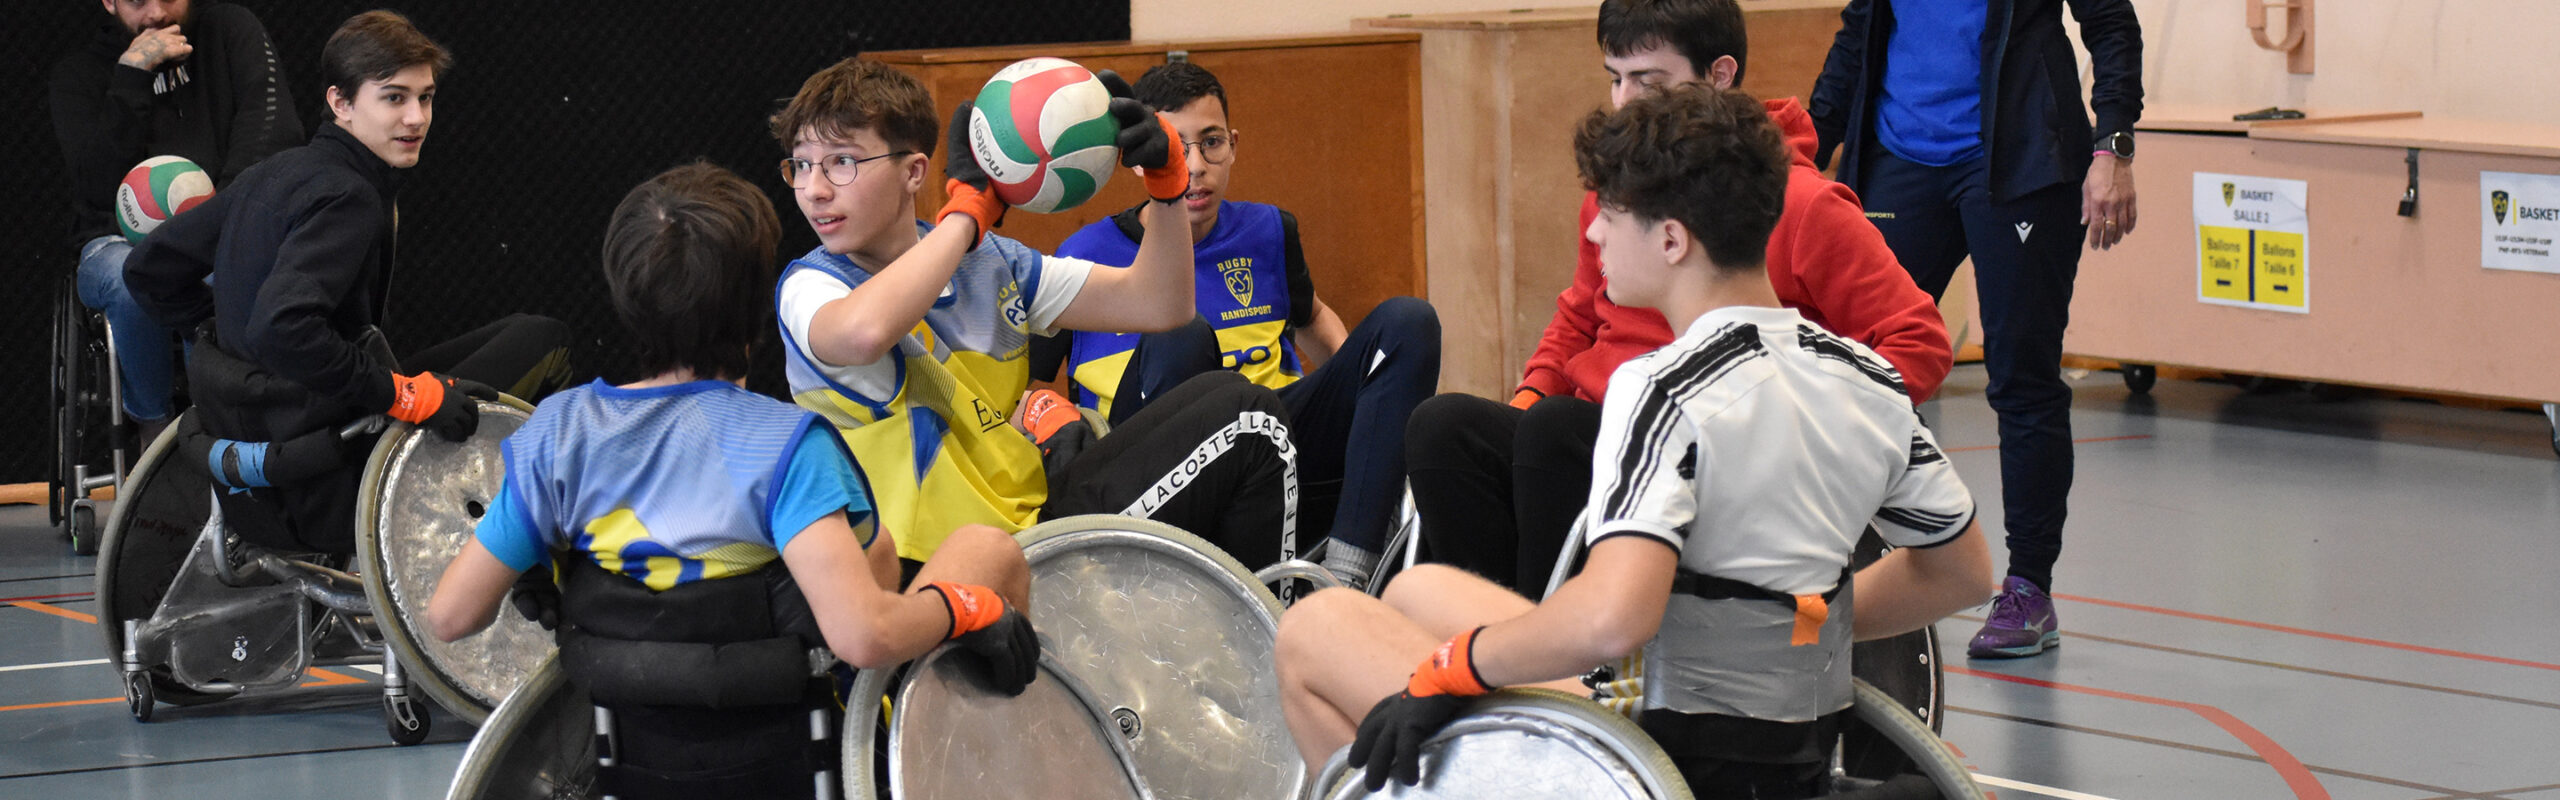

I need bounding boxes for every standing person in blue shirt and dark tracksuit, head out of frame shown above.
[1810,0,2143,659]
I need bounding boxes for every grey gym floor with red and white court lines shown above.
[0,367,2560,800]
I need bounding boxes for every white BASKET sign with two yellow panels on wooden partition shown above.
[2196,172,2312,313]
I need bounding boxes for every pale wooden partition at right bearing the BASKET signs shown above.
[2066,118,2560,403]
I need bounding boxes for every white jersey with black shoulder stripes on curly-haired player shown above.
[1582,308,1974,723]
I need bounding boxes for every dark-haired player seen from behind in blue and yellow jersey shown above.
[428,164,1039,797]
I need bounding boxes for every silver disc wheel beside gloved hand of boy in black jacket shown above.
[356,397,556,736]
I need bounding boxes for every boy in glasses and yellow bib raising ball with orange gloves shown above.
[773,59,1295,567]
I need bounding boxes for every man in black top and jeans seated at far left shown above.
[51,0,302,444]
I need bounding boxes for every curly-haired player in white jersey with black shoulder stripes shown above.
[1280,85,1992,797]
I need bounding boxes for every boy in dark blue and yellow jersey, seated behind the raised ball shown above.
[1032,62,1439,585]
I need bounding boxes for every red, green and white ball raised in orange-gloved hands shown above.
[968,59,1119,213]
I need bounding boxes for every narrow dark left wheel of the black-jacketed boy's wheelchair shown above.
[95,415,230,718]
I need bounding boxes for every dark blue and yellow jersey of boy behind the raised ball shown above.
[1057,200,1316,415]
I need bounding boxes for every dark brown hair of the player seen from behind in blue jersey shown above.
[604,162,783,379]
